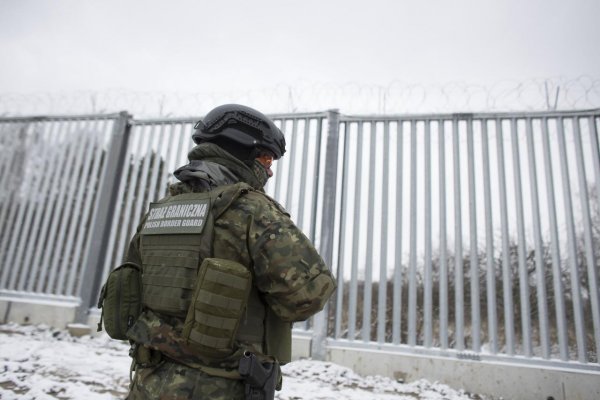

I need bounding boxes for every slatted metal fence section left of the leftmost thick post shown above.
[0,115,123,301]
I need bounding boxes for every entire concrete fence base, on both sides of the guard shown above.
[0,297,600,400]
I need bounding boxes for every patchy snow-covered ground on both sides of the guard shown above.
[0,324,482,400]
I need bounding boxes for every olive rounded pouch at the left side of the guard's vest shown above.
[98,262,142,340]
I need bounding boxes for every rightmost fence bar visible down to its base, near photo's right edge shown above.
[573,117,600,361]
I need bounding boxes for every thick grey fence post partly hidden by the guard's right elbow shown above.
[311,109,340,360]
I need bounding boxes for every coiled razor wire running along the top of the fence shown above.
[0,76,600,118]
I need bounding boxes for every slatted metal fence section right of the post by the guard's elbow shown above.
[330,110,600,369]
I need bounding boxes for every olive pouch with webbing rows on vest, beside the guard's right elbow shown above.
[182,258,252,358]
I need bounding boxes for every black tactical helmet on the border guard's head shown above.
[192,104,285,159]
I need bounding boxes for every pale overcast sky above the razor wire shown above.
[0,0,600,112]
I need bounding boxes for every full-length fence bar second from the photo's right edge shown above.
[558,117,587,363]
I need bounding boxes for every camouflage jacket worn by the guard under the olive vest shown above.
[125,144,336,376]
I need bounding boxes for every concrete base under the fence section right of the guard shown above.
[327,346,600,400]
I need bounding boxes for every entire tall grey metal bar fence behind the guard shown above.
[0,110,600,370]
